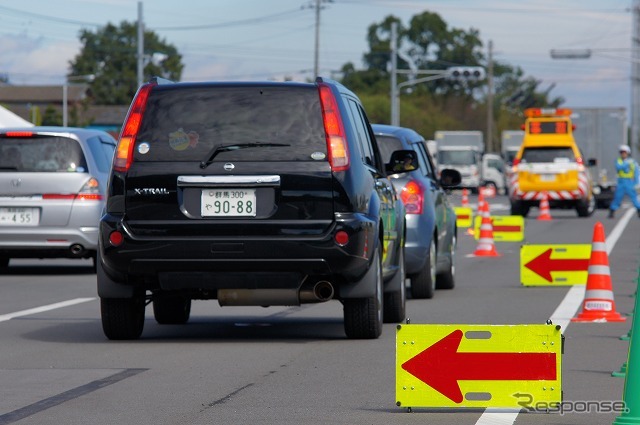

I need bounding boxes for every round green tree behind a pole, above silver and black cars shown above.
[69,21,184,105]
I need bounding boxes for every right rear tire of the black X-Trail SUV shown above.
[343,246,384,339]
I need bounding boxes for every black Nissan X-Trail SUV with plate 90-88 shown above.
[97,78,405,339]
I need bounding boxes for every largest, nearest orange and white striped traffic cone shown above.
[571,222,627,322]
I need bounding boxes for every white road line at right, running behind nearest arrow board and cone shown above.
[476,208,636,425]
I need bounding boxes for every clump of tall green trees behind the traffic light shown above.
[341,11,564,142]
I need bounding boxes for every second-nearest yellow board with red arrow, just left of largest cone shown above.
[520,244,591,286]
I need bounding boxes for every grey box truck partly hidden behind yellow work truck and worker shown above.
[571,108,627,208]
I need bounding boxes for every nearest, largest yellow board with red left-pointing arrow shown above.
[396,324,562,410]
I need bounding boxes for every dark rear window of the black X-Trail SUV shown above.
[134,85,327,161]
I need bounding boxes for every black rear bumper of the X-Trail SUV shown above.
[100,214,378,298]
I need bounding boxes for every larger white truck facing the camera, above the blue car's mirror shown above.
[434,130,484,193]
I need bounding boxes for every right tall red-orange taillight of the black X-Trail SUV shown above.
[318,83,349,171]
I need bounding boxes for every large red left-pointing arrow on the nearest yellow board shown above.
[402,329,556,403]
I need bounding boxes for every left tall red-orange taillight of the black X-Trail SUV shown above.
[113,83,157,172]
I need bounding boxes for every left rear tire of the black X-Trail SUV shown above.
[100,296,145,340]
